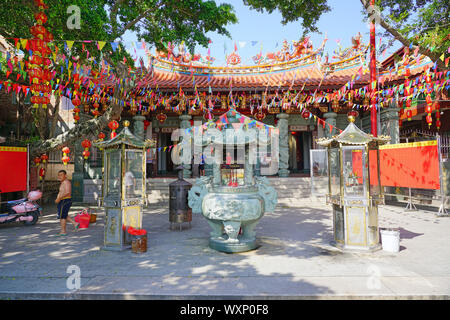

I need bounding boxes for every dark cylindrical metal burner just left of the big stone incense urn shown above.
[169,167,192,230]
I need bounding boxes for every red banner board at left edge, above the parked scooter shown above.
[0,147,27,193]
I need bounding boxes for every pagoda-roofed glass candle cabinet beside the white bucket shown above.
[317,114,390,251]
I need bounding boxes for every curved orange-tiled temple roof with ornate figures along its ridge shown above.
[133,35,432,91]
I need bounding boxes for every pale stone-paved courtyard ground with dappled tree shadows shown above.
[0,198,450,299]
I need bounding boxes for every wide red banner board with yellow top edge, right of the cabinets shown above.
[376,140,440,190]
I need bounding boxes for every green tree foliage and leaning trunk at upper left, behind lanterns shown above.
[0,0,237,153]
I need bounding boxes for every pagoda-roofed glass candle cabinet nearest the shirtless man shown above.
[94,121,154,250]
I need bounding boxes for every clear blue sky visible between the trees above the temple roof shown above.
[123,0,400,66]
